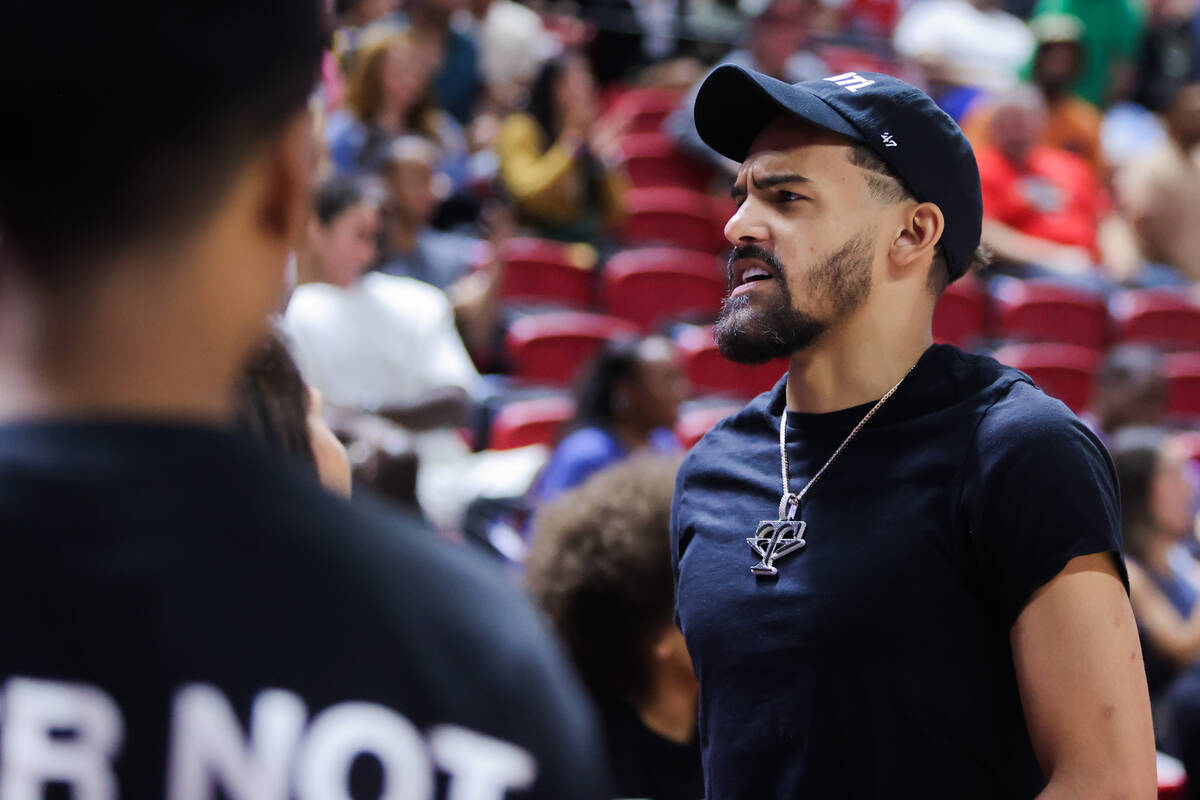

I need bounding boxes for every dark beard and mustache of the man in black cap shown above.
[713,234,871,363]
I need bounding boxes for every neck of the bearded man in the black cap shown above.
[787,314,932,414]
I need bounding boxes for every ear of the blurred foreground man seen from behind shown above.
[259,110,317,245]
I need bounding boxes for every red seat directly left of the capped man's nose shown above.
[620,188,728,253]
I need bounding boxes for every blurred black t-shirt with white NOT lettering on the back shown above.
[0,422,607,800]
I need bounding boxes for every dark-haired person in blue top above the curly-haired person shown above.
[530,336,691,506]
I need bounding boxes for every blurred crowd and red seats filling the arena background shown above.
[270,0,1200,798]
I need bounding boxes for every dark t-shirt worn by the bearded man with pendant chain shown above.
[672,345,1124,799]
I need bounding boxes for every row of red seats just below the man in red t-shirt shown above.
[934,278,1200,350]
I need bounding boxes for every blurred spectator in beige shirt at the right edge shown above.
[1116,82,1200,281]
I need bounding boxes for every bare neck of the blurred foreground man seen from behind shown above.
[0,267,241,423]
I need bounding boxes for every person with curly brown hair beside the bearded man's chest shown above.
[526,455,704,800]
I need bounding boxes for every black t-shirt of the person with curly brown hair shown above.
[600,703,704,800]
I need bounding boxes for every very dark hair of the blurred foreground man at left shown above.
[0,0,325,282]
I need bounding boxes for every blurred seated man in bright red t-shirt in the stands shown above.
[976,86,1108,279]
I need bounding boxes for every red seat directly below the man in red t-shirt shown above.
[992,279,1111,350]
